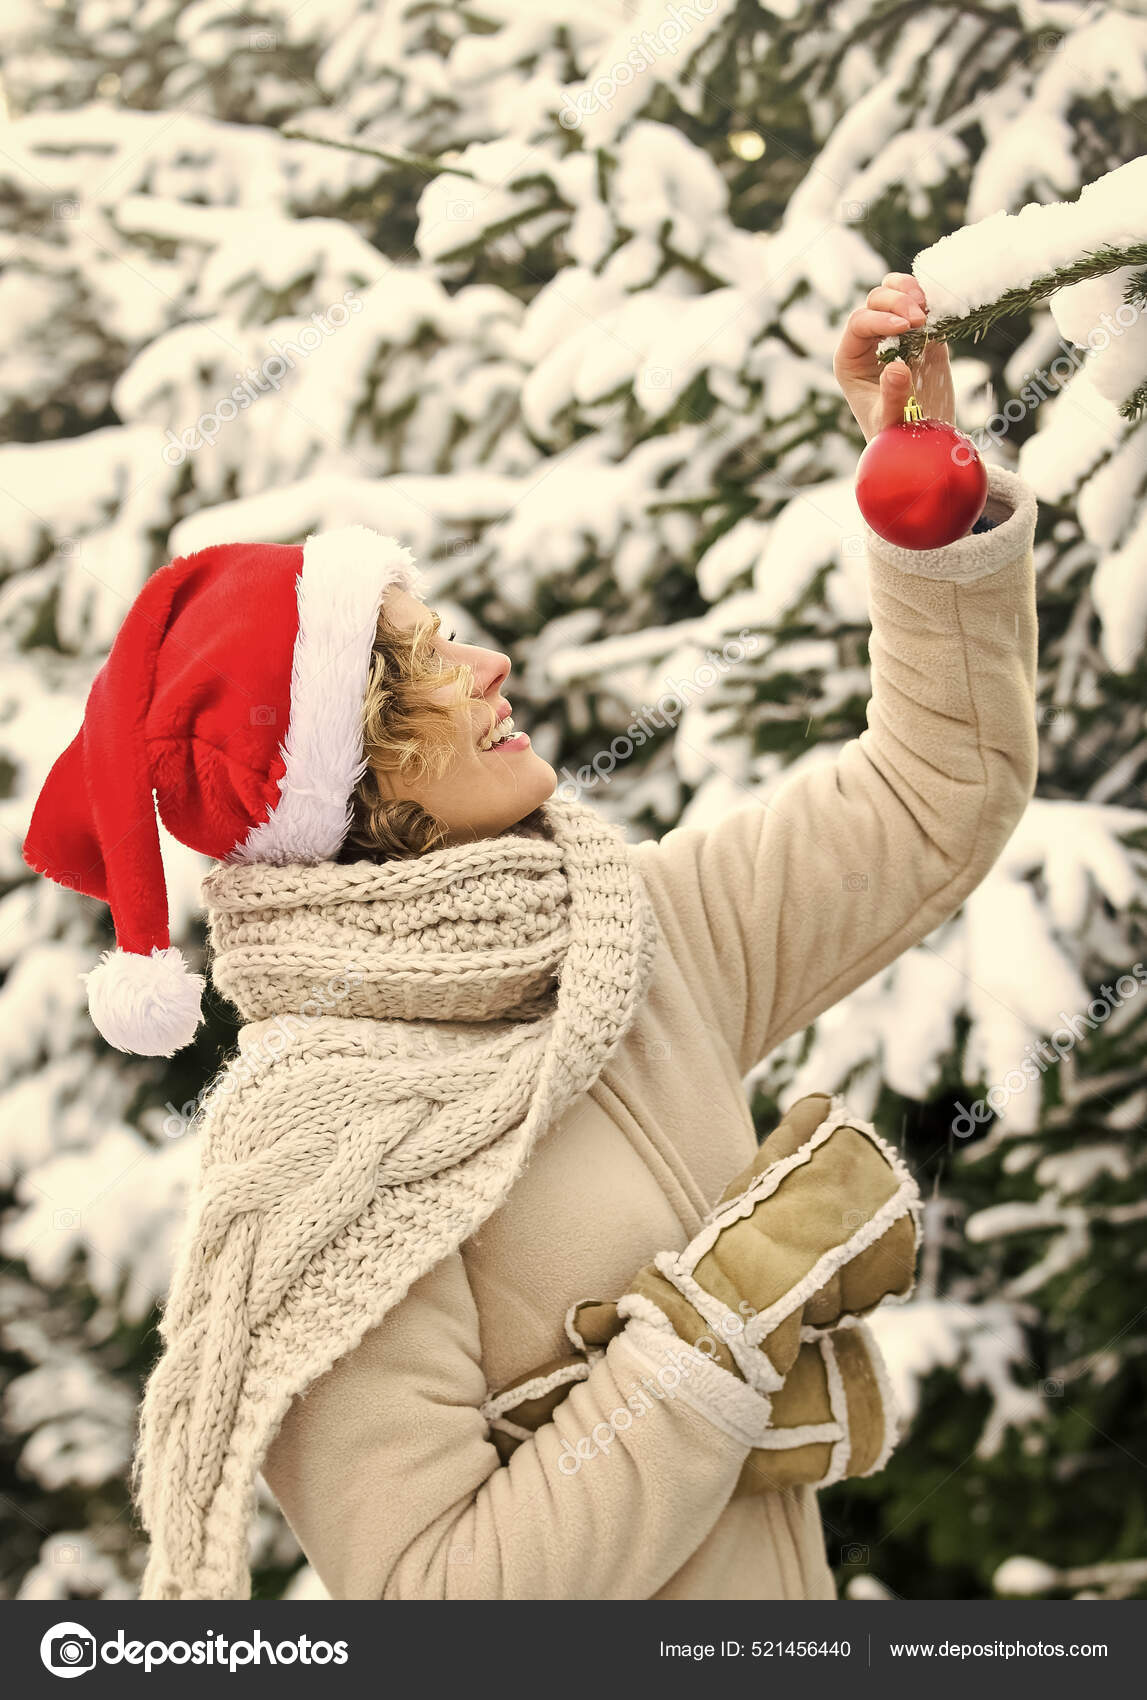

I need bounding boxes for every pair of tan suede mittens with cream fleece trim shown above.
[483,1095,919,1498]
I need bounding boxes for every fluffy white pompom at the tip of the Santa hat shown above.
[80,945,204,1057]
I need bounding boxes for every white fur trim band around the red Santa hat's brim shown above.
[228,525,427,865]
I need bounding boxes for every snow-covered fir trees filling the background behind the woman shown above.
[0,0,1147,1600]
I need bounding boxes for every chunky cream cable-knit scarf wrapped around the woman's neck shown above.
[134,802,656,1600]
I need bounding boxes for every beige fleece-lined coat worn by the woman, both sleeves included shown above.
[263,469,1037,1600]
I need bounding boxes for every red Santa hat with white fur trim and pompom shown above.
[24,525,425,1057]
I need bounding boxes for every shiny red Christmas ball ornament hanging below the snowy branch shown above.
[856,418,987,549]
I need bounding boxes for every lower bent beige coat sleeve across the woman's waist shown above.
[263,1253,765,1600]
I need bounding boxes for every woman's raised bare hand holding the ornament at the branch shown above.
[833,272,955,442]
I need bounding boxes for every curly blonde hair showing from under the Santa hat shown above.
[340,612,498,862]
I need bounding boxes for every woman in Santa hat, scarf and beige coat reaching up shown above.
[25,274,1037,1600]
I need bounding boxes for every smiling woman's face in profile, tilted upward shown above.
[377,587,557,843]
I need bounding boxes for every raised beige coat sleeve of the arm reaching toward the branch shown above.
[636,468,1037,1073]
